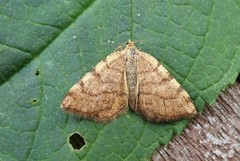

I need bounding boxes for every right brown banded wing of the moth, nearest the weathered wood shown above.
[133,52,196,122]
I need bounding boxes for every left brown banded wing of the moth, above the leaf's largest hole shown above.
[61,51,128,122]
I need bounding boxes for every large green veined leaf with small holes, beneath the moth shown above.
[0,0,240,160]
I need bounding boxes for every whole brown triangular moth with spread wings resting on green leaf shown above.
[61,41,197,122]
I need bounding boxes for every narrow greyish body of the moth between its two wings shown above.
[126,48,137,108]
